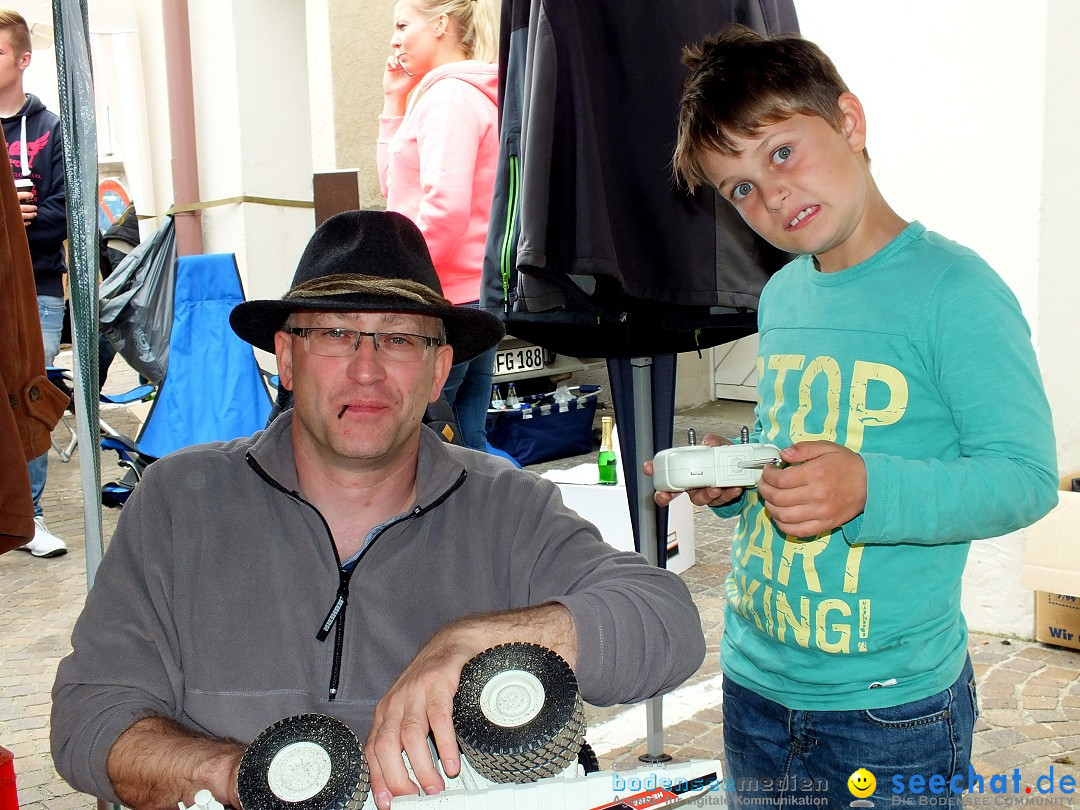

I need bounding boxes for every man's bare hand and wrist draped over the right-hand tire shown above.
[364,603,578,810]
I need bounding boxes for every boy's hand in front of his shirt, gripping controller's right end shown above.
[757,442,866,537]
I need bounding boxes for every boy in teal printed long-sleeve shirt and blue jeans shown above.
[657,26,1057,807]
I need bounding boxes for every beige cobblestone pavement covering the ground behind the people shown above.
[0,355,1080,810]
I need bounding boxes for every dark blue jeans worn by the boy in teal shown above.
[724,658,978,808]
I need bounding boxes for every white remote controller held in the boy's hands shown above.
[652,444,780,492]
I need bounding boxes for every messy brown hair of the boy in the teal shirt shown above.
[674,23,848,190]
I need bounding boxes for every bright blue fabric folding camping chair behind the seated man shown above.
[102,254,271,507]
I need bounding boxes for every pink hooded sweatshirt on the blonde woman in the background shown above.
[378,59,499,303]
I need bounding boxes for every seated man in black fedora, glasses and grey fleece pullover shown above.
[52,212,704,808]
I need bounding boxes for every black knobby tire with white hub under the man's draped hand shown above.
[454,643,585,784]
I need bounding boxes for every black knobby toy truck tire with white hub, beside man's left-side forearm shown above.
[237,714,369,810]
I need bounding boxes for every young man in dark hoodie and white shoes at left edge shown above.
[0,9,67,557]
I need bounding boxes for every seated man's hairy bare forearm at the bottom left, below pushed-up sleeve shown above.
[106,717,245,810]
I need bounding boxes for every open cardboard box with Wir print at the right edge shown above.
[1021,488,1080,650]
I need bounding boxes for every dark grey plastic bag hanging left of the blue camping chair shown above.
[98,217,176,382]
